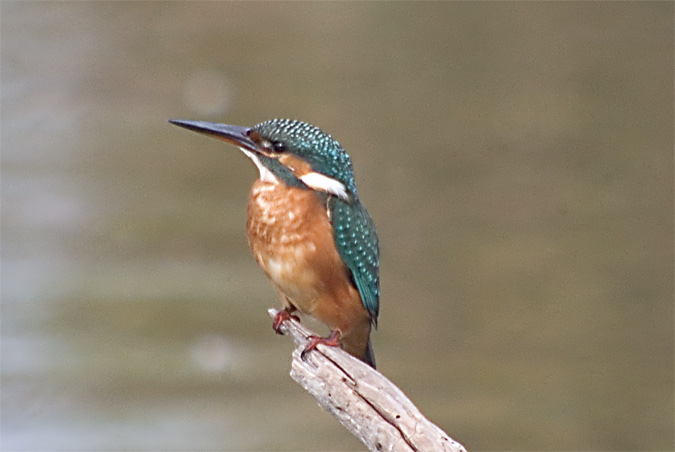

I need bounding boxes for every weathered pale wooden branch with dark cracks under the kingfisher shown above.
[269,309,466,452]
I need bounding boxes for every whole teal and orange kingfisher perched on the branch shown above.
[169,119,380,368]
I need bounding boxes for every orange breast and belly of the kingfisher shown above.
[247,180,370,348]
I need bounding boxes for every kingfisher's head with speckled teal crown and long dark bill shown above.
[169,119,357,202]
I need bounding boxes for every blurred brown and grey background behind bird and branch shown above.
[0,1,674,451]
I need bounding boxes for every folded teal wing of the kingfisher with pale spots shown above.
[329,196,380,325]
